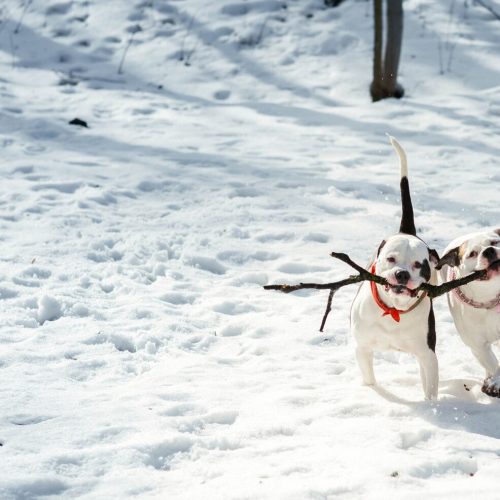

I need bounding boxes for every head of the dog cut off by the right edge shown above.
[437,229,500,280]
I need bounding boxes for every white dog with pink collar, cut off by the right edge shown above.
[436,229,500,397]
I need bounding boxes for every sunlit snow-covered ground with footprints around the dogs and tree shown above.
[0,0,500,500]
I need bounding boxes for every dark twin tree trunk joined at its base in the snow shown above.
[370,0,404,102]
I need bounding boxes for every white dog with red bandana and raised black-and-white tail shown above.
[351,137,439,399]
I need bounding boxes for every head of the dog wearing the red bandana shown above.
[375,234,439,307]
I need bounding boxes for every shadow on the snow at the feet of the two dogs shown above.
[372,379,500,439]
